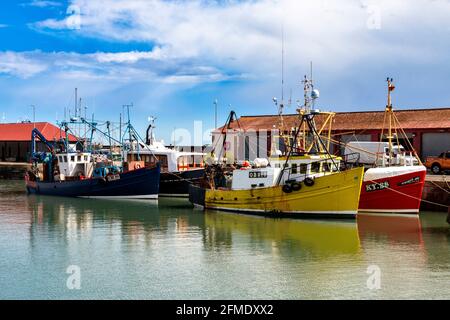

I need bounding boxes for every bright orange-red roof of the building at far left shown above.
[0,122,77,142]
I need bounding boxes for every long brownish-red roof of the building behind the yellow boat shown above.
[218,108,450,131]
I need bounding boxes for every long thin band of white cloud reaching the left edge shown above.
[0,47,241,84]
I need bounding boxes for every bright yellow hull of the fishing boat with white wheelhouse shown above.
[205,167,364,216]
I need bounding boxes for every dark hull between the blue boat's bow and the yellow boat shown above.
[159,169,205,198]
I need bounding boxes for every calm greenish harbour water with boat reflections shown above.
[0,181,450,299]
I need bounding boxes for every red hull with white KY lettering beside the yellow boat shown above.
[359,171,426,213]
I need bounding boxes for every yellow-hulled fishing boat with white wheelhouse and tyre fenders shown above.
[189,77,364,218]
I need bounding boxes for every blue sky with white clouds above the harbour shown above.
[0,0,450,141]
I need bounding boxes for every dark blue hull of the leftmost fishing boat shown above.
[27,165,161,199]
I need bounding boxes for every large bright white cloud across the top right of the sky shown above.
[30,0,450,76]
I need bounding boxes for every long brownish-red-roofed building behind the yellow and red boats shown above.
[212,108,450,160]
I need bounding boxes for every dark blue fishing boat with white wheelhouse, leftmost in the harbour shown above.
[25,125,161,199]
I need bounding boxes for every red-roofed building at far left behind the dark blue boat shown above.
[0,122,77,162]
